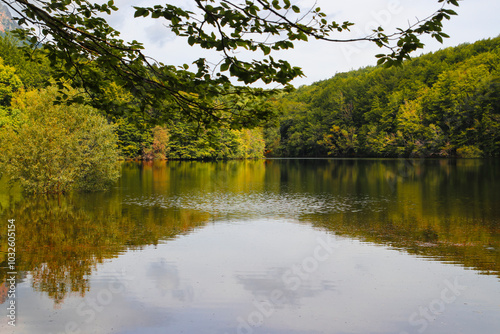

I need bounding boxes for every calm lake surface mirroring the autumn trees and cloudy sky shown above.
[0,160,500,334]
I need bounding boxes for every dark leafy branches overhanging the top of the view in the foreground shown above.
[2,0,458,128]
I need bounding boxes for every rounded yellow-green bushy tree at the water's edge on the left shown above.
[0,87,119,193]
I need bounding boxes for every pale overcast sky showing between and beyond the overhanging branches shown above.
[103,0,500,86]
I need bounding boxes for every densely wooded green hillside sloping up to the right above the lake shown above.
[265,37,500,157]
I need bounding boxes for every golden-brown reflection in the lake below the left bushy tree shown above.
[0,195,207,305]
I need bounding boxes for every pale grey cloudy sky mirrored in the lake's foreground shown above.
[0,220,500,334]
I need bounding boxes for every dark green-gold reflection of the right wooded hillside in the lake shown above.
[292,159,500,277]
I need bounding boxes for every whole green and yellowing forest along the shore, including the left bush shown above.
[0,35,500,192]
